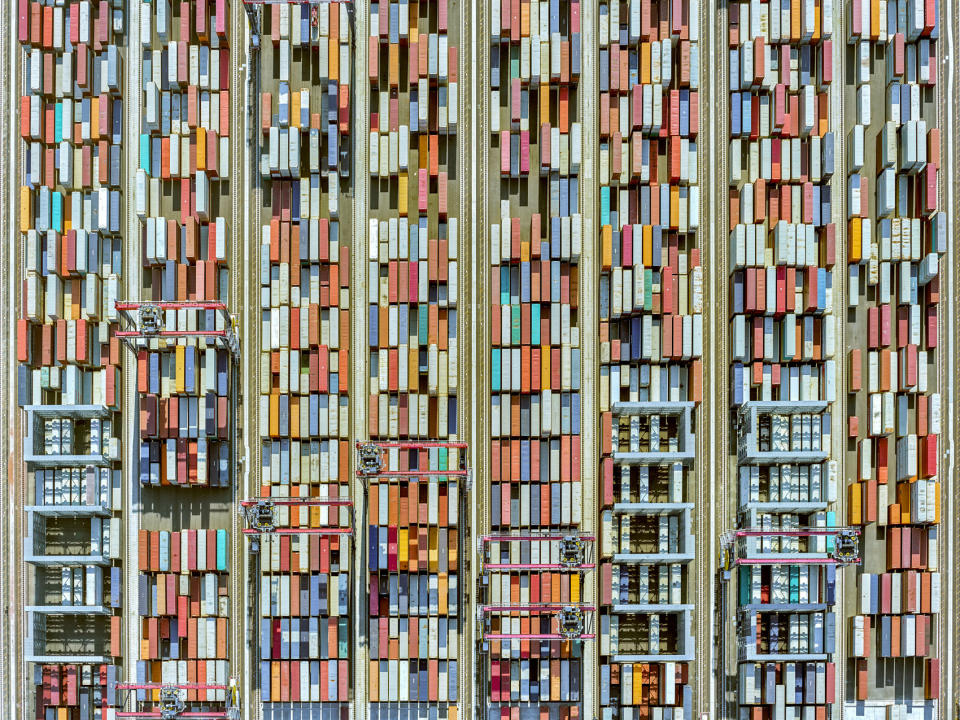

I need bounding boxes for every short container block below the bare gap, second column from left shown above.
[136,530,232,710]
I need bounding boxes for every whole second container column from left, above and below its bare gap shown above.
[130,0,235,710]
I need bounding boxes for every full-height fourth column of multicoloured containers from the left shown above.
[366,0,464,720]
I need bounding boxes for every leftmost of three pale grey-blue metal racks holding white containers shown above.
[22,405,120,664]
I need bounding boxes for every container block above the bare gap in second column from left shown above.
[133,0,232,487]
